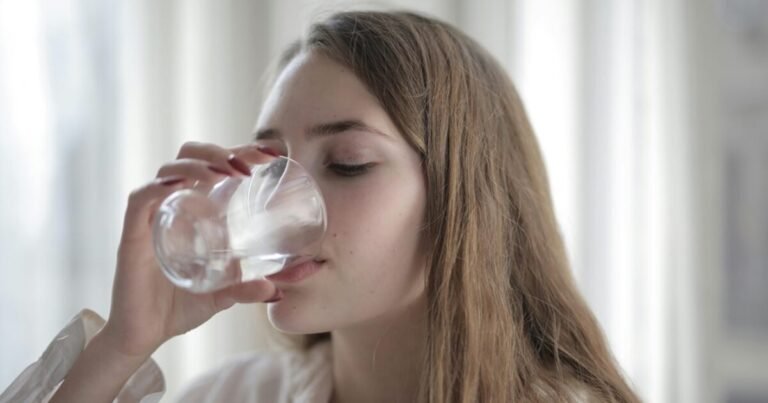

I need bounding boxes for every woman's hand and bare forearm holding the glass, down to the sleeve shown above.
[51,143,279,403]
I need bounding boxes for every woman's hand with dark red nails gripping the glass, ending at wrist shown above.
[101,143,278,357]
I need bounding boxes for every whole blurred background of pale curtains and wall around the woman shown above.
[0,0,768,403]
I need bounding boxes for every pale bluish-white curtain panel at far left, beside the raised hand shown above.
[0,1,124,388]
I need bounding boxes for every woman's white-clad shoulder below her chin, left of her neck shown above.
[179,343,331,402]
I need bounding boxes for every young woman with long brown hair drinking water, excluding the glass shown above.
[7,12,639,402]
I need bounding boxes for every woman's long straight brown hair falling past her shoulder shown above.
[272,11,639,402]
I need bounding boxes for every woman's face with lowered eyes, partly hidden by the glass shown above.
[257,52,426,333]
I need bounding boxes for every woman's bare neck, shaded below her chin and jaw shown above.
[331,299,426,403]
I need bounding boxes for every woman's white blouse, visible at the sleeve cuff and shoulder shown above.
[0,309,333,403]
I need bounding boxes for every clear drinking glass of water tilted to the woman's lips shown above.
[153,156,326,292]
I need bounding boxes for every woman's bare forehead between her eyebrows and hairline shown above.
[257,51,384,127]
